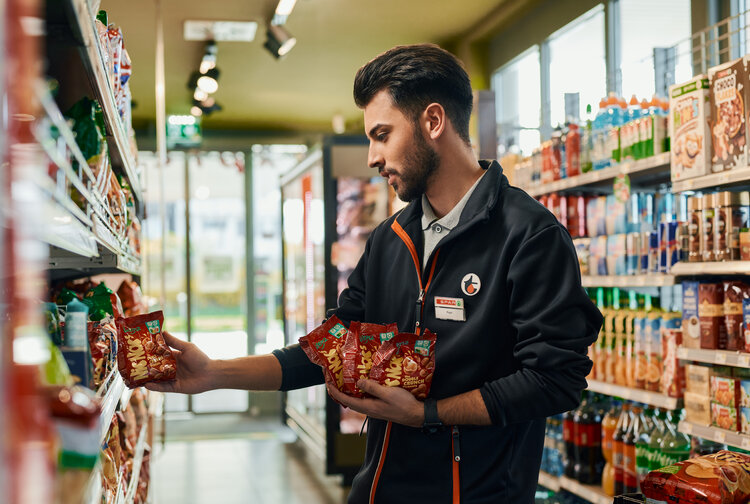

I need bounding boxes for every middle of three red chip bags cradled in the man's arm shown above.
[341,322,398,397]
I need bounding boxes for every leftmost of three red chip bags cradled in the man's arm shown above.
[299,316,347,391]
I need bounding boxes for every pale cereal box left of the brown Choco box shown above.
[669,75,711,180]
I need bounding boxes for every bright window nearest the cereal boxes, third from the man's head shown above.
[620,0,693,100]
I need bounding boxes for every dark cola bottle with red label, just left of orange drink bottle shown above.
[574,392,602,485]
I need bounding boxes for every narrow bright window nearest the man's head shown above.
[492,46,541,155]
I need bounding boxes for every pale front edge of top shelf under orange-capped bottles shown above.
[526,152,669,196]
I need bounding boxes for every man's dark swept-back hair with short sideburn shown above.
[354,44,473,143]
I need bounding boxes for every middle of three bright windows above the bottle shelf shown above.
[547,5,607,127]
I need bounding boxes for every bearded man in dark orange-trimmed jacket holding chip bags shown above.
[149,45,602,504]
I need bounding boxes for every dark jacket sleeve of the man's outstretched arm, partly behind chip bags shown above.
[273,227,370,391]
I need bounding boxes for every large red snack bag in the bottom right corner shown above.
[641,450,750,504]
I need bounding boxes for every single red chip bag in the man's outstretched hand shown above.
[117,310,177,388]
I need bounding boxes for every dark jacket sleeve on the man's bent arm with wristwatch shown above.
[480,224,602,425]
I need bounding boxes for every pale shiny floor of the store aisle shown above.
[151,415,347,504]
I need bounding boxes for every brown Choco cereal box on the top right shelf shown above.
[708,58,747,172]
